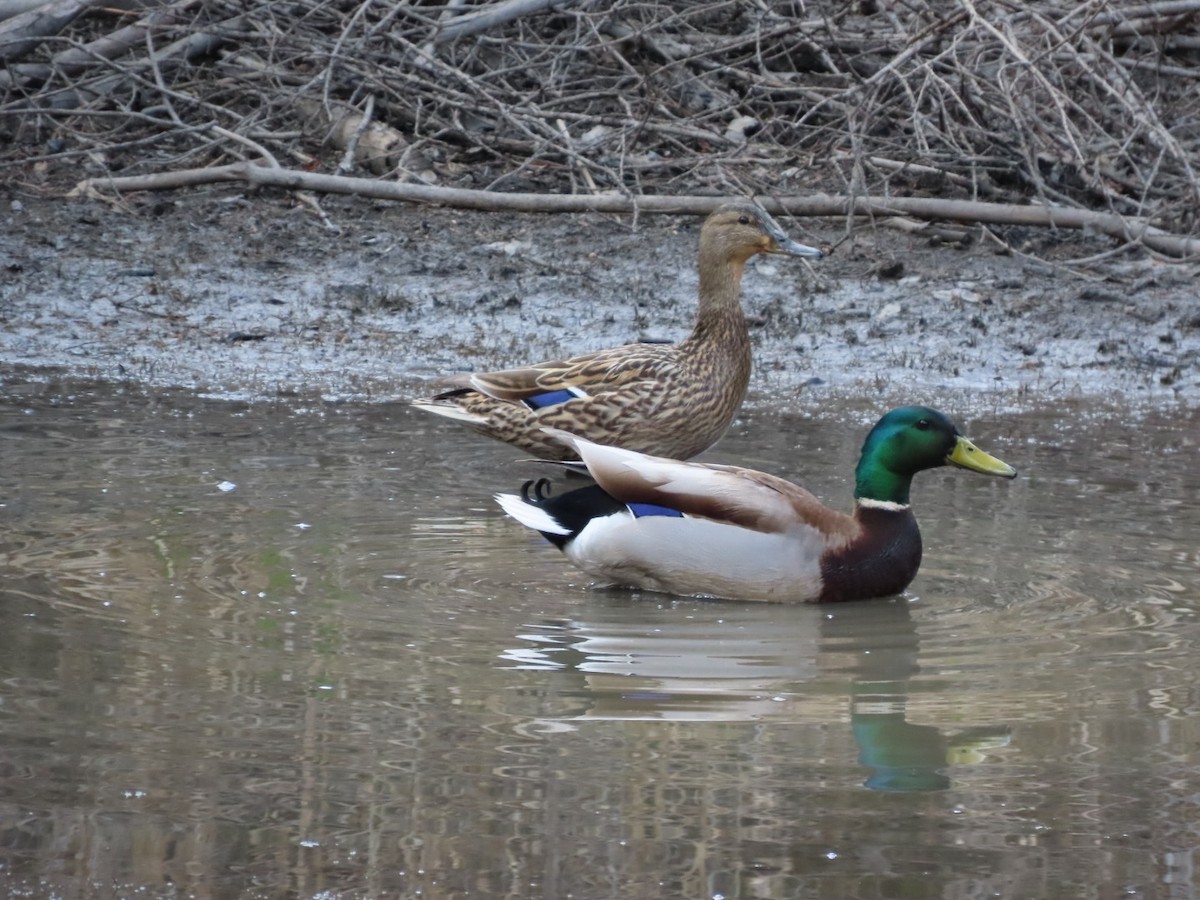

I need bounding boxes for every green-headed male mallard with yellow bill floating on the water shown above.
[496,407,1016,602]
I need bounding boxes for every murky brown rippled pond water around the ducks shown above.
[0,378,1200,900]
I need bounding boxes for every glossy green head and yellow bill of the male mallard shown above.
[854,407,1016,504]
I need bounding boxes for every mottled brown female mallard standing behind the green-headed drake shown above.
[414,200,822,460]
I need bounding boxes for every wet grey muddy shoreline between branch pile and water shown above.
[0,188,1200,415]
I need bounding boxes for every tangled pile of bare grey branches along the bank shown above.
[0,0,1200,240]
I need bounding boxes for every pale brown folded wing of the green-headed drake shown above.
[546,428,858,544]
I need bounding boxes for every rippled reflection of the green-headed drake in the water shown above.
[503,595,1009,792]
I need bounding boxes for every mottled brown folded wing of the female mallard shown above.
[443,343,678,401]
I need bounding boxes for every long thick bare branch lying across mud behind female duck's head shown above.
[71,163,1200,257]
